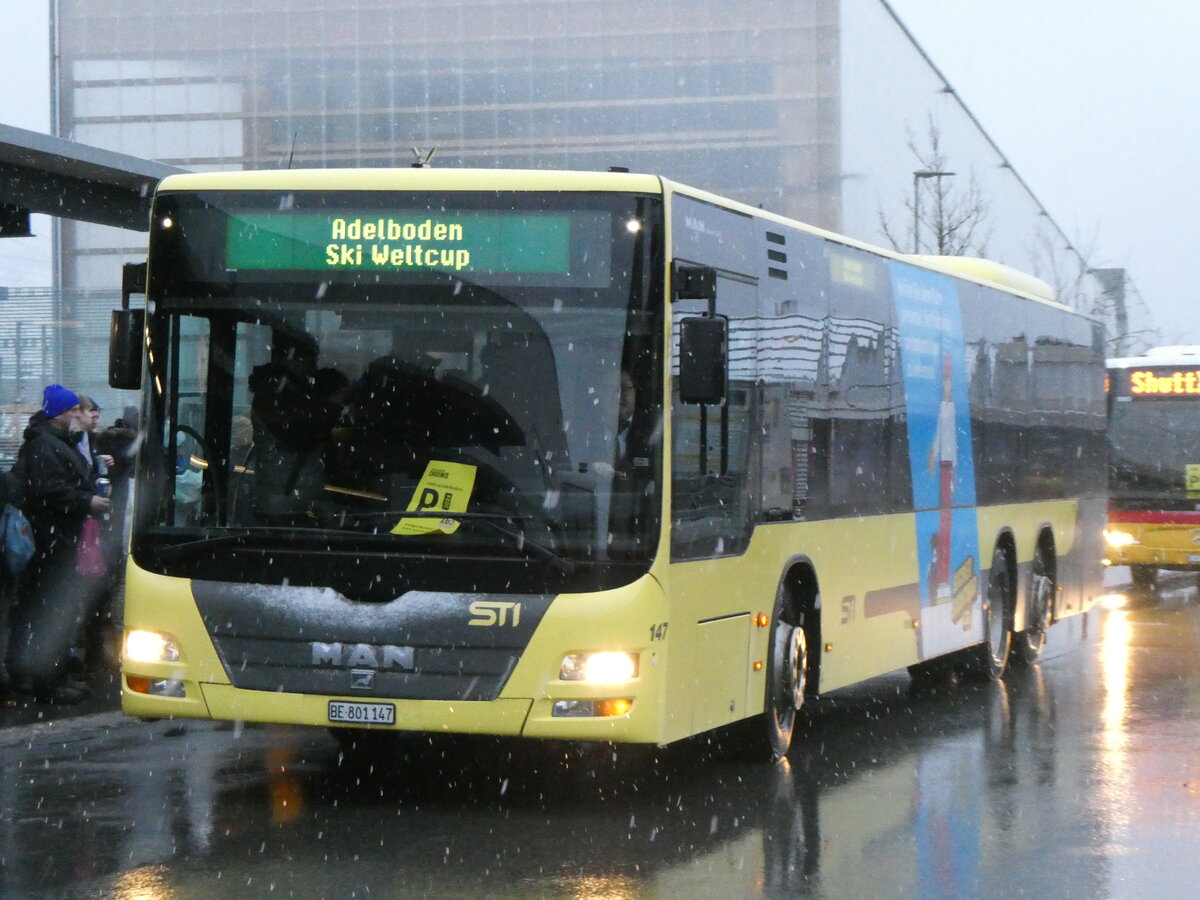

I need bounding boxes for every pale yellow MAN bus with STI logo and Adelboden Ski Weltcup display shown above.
[110,168,1105,758]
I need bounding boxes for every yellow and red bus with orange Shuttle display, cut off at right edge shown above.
[1105,347,1200,599]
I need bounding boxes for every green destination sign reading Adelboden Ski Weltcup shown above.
[226,211,571,274]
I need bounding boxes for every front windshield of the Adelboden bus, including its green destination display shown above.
[132,191,662,595]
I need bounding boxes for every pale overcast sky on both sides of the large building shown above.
[0,0,1200,342]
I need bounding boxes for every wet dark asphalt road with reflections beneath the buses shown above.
[0,584,1200,900]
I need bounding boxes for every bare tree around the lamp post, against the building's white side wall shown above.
[880,116,991,257]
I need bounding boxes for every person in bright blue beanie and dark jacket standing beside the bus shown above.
[8,384,109,703]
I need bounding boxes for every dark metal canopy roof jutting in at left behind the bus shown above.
[0,125,185,232]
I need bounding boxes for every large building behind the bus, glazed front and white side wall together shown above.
[44,0,1123,415]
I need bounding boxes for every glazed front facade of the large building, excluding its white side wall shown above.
[59,0,840,287]
